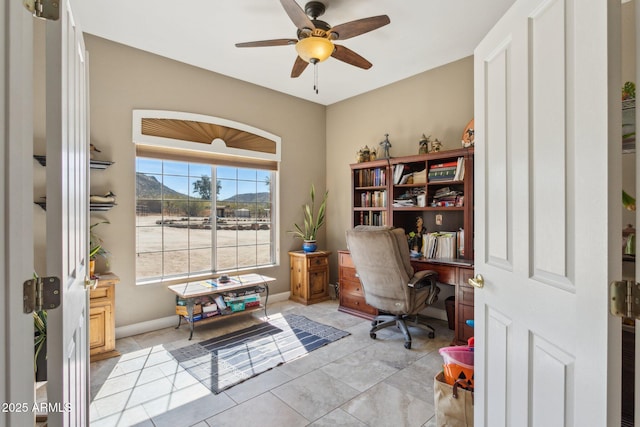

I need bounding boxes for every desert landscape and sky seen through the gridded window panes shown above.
[136,156,276,283]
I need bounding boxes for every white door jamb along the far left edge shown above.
[0,0,35,426]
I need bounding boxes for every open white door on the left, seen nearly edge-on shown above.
[46,0,89,426]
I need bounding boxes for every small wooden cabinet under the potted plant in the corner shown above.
[289,251,331,305]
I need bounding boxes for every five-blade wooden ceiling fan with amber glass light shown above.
[236,0,391,78]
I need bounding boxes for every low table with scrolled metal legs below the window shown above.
[169,274,276,339]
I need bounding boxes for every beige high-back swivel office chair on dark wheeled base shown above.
[346,225,440,349]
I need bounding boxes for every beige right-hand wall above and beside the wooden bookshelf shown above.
[327,57,473,307]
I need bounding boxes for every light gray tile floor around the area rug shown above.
[91,301,453,427]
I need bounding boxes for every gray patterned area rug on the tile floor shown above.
[169,314,349,394]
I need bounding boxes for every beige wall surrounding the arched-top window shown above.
[64,36,326,327]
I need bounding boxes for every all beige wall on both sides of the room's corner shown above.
[34,26,473,327]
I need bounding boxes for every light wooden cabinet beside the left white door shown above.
[89,273,120,362]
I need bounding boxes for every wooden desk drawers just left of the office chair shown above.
[338,251,378,319]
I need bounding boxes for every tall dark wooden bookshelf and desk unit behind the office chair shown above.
[338,148,474,345]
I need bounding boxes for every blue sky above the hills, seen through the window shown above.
[136,157,271,200]
